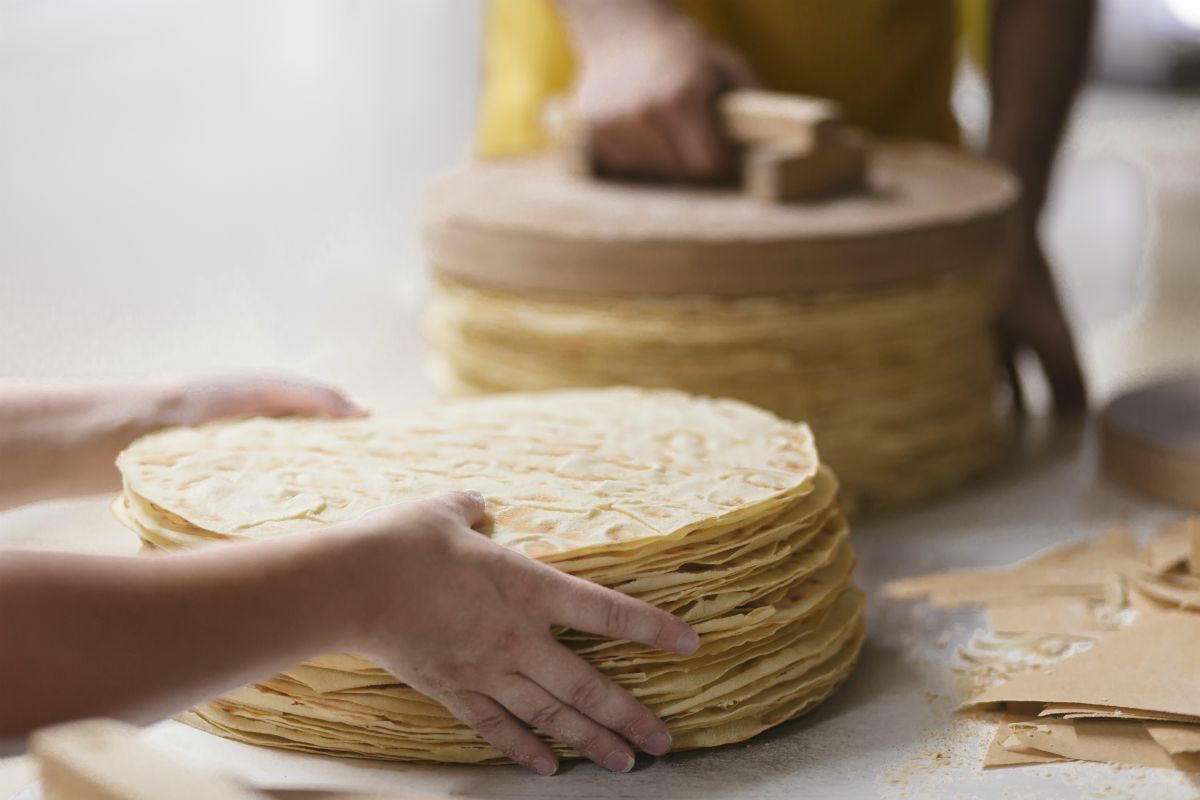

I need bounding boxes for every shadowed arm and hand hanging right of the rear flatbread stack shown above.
[988,0,1096,415]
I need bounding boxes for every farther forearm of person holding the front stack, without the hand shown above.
[0,381,180,509]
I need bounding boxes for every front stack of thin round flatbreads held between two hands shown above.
[114,389,863,763]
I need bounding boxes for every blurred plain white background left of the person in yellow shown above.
[0,0,480,410]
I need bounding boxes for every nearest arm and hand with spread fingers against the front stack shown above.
[0,492,700,774]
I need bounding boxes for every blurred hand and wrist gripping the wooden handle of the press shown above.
[559,0,754,179]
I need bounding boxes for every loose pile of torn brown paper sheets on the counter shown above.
[886,519,1200,771]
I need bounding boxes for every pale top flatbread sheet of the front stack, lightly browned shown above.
[118,389,818,561]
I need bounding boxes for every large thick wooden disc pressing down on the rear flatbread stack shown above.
[422,143,1018,295]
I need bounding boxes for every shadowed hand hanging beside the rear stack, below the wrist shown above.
[998,223,1087,417]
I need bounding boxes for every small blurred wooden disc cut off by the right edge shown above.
[1100,377,1200,510]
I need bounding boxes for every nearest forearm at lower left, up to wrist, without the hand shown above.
[0,534,362,741]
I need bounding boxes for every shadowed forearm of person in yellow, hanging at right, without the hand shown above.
[988,0,1096,223]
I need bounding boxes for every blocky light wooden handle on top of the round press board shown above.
[556,89,868,203]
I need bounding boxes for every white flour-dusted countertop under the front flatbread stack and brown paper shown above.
[0,424,1200,800]
